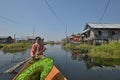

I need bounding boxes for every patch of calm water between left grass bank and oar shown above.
[0,49,29,72]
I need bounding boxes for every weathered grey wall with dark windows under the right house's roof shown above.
[90,29,120,40]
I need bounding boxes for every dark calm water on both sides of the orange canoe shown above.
[0,45,120,80]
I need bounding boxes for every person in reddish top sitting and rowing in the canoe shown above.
[30,37,46,58]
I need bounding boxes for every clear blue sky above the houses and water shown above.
[0,0,120,41]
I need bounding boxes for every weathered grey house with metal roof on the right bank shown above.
[81,23,120,43]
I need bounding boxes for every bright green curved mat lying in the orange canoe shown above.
[16,57,54,80]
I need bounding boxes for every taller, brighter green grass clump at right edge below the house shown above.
[89,42,120,59]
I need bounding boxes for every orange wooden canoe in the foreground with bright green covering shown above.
[12,57,67,80]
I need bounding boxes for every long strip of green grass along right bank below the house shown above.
[65,41,120,59]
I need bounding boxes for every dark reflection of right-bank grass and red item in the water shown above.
[71,51,120,69]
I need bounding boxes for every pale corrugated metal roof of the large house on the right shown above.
[87,23,120,29]
